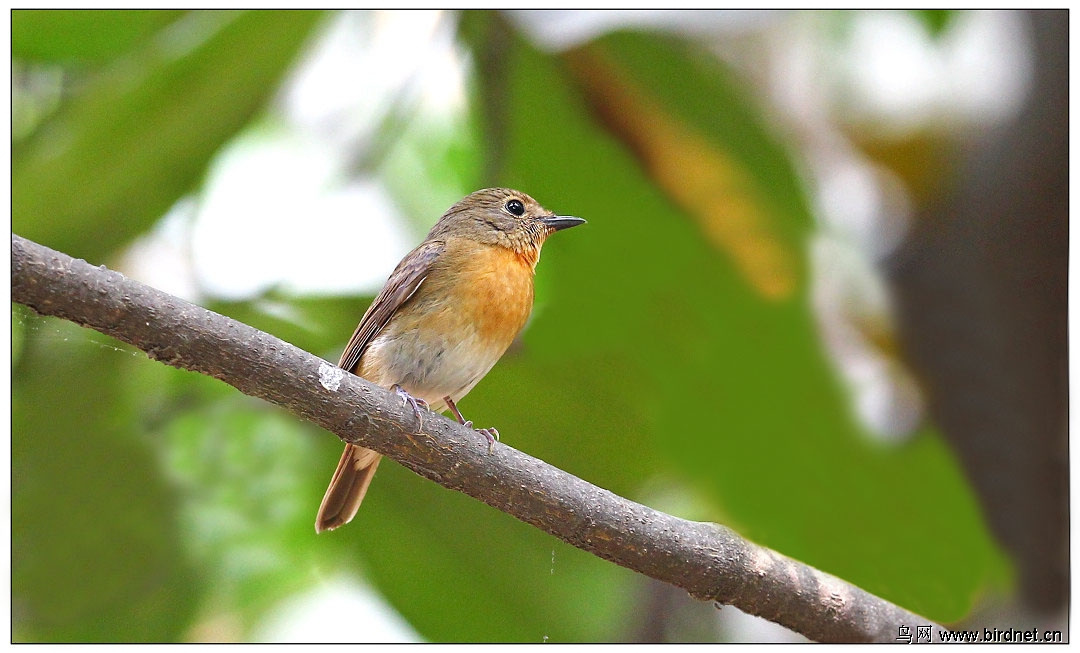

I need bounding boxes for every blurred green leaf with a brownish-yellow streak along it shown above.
[565,33,811,300]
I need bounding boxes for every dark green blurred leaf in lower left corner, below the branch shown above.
[11,311,200,641]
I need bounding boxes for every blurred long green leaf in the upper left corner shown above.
[12,12,321,260]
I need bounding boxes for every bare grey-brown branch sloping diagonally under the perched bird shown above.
[11,234,930,641]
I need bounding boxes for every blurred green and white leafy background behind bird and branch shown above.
[12,11,1068,642]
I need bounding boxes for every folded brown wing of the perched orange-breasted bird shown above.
[338,241,446,371]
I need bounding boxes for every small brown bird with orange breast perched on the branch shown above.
[315,188,585,532]
